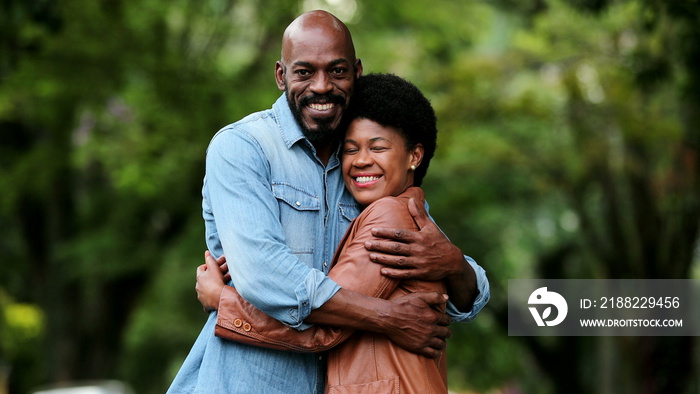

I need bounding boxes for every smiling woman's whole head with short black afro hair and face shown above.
[343,74,437,205]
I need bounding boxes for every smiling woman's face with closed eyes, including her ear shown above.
[342,119,423,206]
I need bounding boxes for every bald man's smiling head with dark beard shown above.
[275,11,362,146]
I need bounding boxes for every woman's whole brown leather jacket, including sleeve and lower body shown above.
[216,187,447,394]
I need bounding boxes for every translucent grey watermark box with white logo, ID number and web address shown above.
[508,278,700,338]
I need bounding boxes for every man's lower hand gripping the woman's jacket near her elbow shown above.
[384,293,452,358]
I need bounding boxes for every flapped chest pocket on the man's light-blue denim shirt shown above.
[272,182,321,258]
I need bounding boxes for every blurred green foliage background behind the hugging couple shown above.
[0,0,700,394]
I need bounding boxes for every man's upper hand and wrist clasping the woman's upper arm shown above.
[365,198,477,311]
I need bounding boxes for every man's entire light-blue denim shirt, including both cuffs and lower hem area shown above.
[168,95,490,393]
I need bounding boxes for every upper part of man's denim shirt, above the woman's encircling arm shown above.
[202,95,361,329]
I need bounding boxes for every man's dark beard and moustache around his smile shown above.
[284,90,345,145]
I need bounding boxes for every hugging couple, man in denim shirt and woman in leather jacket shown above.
[168,11,489,394]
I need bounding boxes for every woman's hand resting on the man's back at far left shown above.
[194,251,231,311]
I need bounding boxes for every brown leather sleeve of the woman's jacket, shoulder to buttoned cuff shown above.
[215,198,417,352]
